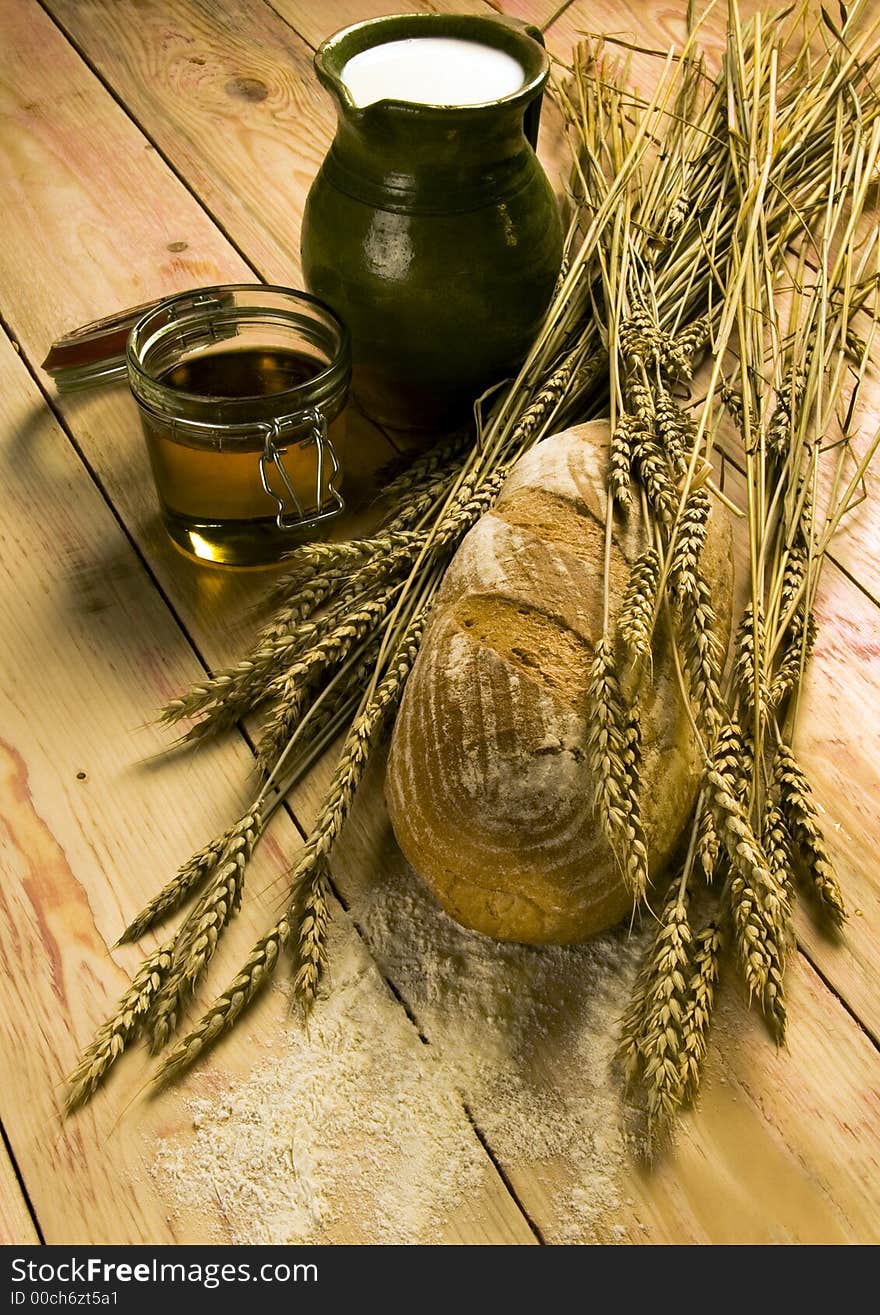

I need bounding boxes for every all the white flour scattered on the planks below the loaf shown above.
[153,831,634,1244]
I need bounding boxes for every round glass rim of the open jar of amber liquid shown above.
[125,283,351,413]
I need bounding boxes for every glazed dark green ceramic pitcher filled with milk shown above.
[303,13,563,430]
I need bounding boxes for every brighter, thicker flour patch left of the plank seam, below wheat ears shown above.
[151,932,485,1244]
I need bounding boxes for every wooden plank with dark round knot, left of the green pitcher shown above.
[43,0,328,285]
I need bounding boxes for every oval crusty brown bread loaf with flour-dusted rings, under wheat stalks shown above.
[385,421,733,943]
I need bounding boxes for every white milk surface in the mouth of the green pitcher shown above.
[342,37,525,105]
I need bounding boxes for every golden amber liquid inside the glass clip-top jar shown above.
[141,347,343,565]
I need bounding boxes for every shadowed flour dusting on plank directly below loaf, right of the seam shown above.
[353,859,642,1243]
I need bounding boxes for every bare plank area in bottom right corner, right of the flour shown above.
[555,959,880,1245]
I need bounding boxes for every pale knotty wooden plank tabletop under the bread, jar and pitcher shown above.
[0,0,880,1244]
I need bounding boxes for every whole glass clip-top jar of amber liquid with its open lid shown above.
[45,284,351,565]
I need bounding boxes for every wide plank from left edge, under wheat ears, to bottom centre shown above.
[0,323,533,1243]
